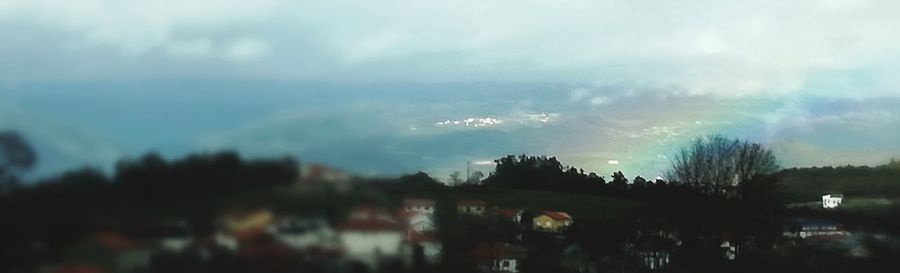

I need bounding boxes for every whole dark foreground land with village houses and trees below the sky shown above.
[0,131,900,273]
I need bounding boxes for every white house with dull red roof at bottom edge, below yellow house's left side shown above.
[466,242,528,273]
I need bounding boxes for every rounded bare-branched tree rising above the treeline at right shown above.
[669,135,778,192]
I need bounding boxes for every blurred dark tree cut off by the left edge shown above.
[0,131,37,193]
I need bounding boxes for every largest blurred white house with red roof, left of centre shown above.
[339,206,405,270]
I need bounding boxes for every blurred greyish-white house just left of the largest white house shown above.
[272,217,338,250]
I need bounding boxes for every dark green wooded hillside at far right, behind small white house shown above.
[781,159,900,202]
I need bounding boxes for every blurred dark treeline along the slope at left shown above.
[0,152,297,268]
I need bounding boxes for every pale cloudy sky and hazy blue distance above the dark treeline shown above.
[0,0,900,182]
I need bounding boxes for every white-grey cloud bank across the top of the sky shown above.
[0,0,900,98]
